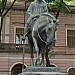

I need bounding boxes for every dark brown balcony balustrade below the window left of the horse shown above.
[0,43,29,53]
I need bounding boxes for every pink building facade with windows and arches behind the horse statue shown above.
[0,1,75,75]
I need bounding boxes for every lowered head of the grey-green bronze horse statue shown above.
[46,17,57,45]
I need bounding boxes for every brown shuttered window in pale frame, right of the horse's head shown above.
[67,30,75,47]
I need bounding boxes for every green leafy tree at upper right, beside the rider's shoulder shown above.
[48,0,75,19]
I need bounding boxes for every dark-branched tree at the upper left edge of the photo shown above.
[0,0,16,43]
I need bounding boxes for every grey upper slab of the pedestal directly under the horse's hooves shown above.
[22,67,59,72]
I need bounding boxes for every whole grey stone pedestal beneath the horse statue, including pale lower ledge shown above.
[19,67,67,75]
